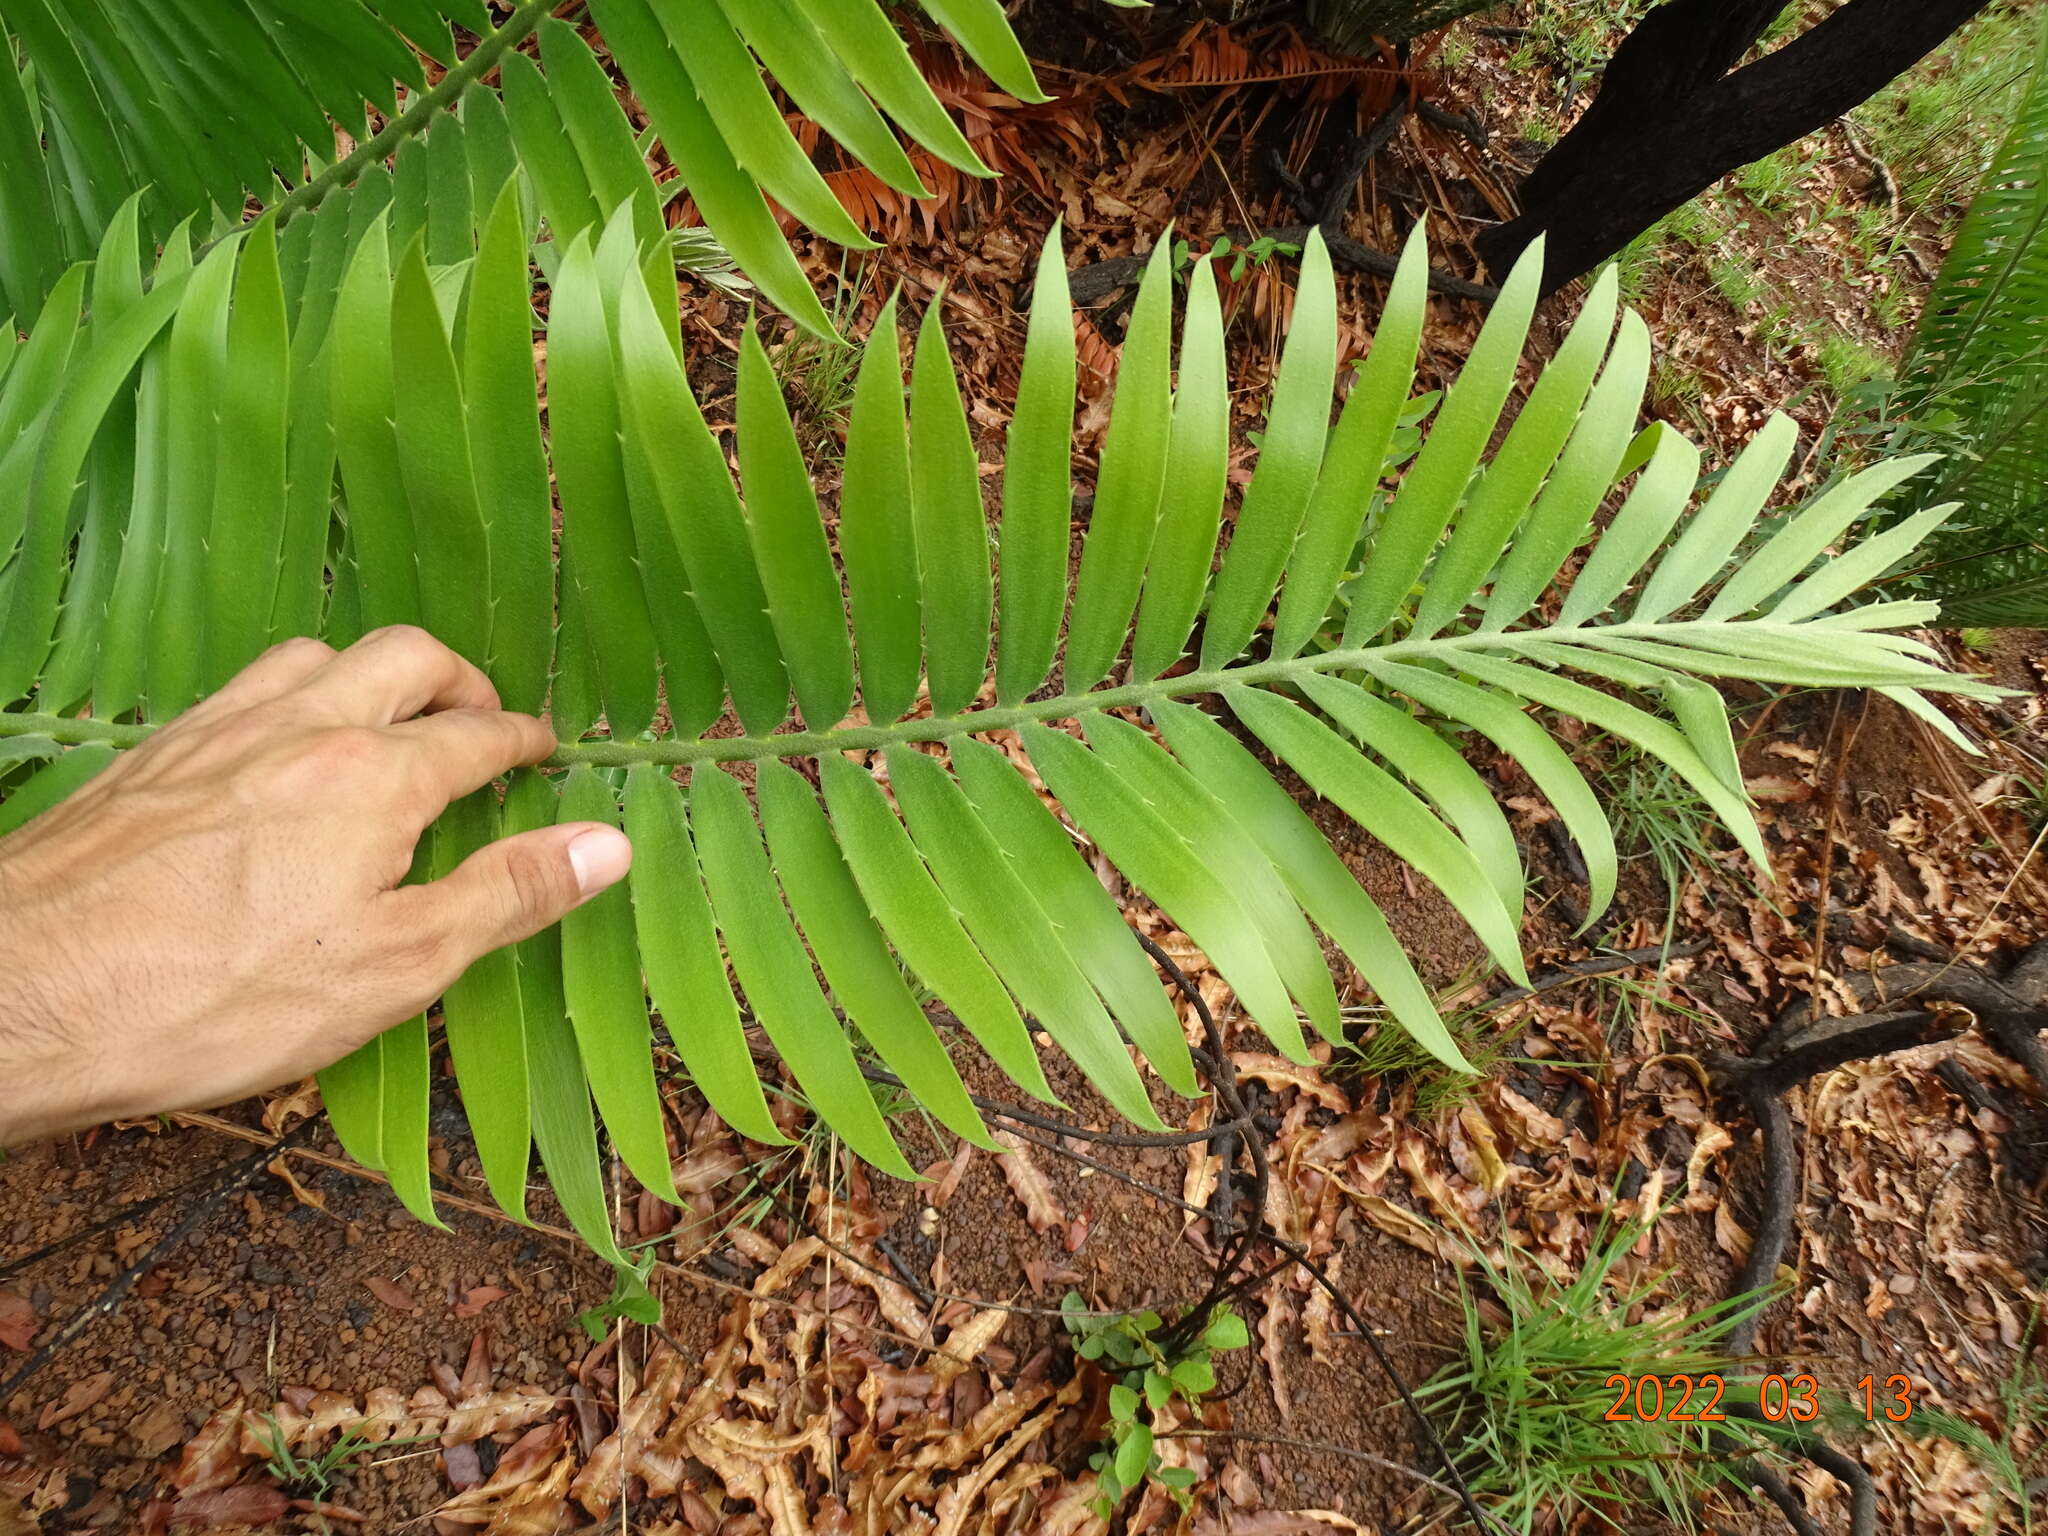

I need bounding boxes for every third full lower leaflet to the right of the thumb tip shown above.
[756,762,999,1151]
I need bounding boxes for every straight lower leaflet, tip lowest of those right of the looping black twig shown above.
[1153,702,1473,1071]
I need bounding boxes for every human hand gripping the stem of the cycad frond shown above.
[0,627,633,1147]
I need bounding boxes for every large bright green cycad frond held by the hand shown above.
[0,178,1989,1257]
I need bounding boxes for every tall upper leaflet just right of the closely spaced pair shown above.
[1202,229,1337,668]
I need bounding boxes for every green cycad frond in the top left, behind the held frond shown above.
[0,0,1042,332]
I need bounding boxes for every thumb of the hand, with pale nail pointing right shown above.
[391,821,633,977]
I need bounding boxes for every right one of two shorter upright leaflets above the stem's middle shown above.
[909,301,995,715]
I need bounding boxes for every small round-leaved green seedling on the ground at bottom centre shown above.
[1059,1290,1251,1520]
